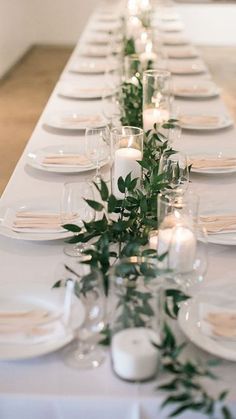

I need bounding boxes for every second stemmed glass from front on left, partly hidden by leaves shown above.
[61,182,95,257]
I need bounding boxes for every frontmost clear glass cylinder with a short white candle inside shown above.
[109,257,161,381]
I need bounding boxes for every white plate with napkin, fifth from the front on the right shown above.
[174,80,220,99]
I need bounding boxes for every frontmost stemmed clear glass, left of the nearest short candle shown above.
[63,264,106,369]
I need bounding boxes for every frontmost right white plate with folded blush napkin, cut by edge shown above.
[178,286,236,362]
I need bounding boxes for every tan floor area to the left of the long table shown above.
[0,46,72,194]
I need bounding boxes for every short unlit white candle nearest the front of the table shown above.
[111,327,158,381]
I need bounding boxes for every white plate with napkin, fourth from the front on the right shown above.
[179,114,233,131]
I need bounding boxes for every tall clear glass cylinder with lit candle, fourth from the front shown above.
[143,69,171,131]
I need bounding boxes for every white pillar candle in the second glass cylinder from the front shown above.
[157,226,197,273]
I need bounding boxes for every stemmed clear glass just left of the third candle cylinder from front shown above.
[85,126,111,183]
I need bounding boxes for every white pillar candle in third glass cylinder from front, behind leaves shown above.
[113,147,142,197]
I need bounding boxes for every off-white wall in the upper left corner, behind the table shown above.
[0,0,98,78]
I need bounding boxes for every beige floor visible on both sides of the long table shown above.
[0,46,236,194]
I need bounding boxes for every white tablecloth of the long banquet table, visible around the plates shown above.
[0,1,236,419]
